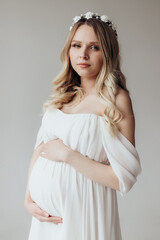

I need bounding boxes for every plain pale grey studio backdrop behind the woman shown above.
[0,0,160,240]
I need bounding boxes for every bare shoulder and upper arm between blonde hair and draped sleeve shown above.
[116,88,135,146]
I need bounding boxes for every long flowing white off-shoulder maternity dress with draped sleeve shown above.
[28,109,141,240]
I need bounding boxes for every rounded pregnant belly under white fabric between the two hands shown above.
[29,157,73,216]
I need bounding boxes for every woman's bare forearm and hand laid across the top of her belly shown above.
[40,139,119,190]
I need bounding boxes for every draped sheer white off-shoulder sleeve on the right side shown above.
[101,117,142,196]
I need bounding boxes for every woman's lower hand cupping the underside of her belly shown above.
[24,193,63,224]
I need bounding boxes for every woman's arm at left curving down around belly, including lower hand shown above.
[24,142,62,224]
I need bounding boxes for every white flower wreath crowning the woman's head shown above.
[69,12,117,37]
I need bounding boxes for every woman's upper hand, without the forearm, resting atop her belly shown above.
[40,138,72,162]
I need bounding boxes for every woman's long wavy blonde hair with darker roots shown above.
[43,18,129,136]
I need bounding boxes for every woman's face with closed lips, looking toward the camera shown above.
[69,25,103,79]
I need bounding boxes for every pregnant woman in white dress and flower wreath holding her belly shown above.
[24,12,141,240]
